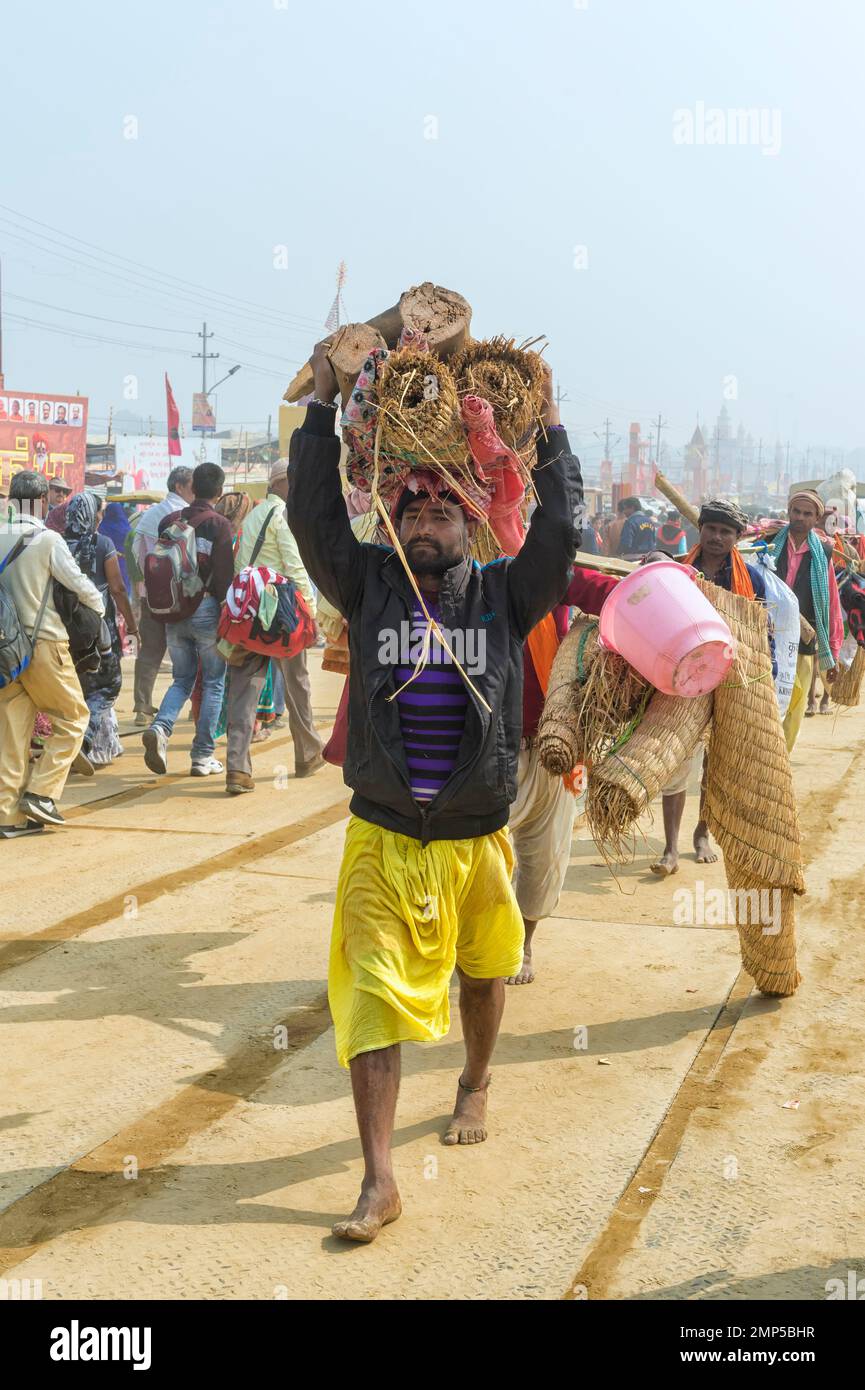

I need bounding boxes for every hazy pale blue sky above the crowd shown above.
[0,0,865,472]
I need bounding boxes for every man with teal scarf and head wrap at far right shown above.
[773,488,844,752]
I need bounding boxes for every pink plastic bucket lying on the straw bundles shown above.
[598,560,736,698]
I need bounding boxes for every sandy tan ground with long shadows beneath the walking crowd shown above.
[0,653,865,1300]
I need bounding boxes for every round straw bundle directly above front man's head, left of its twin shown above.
[377,348,469,468]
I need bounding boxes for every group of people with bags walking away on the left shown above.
[0,460,324,840]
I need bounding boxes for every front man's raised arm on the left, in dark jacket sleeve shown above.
[286,343,363,617]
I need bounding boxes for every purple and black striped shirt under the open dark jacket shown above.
[394,599,469,803]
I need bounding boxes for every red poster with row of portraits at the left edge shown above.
[0,386,88,493]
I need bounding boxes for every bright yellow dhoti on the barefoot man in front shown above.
[328,816,523,1066]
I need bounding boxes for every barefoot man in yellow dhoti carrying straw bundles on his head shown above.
[288,345,581,1241]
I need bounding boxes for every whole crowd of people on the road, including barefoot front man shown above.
[0,366,865,1241]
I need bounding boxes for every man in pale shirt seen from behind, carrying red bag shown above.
[225,459,324,796]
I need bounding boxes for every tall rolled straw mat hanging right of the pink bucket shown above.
[697,580,805,995]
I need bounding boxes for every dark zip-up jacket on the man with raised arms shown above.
[288,404,583,844]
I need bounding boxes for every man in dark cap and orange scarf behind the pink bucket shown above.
[649,498,776,876]
